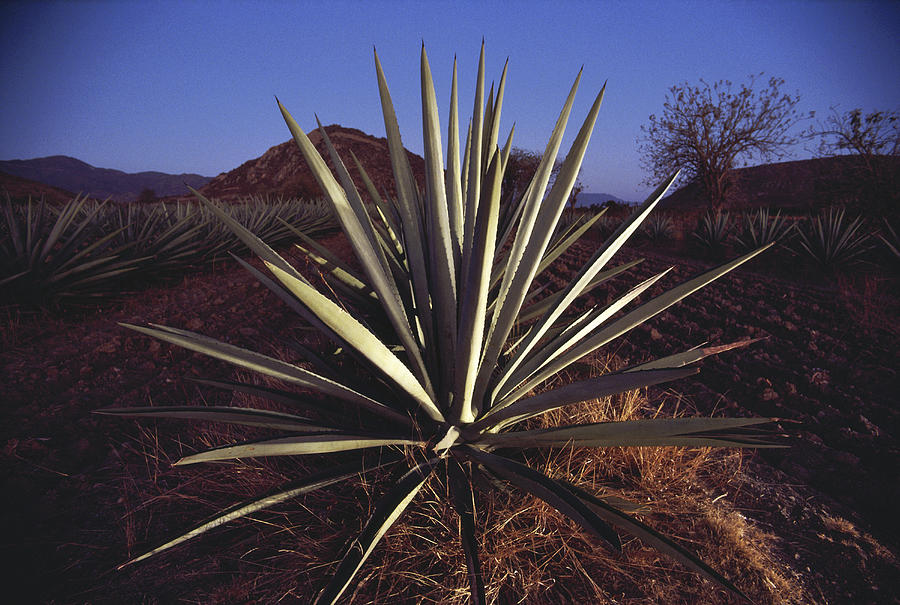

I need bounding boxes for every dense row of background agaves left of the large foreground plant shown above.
[0,196,334,306]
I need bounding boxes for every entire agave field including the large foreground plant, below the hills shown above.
[0,48,900,604]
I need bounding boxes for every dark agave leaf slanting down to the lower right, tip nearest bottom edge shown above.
[567,484,751,603]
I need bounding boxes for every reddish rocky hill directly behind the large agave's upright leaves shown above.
[200,124,425,200]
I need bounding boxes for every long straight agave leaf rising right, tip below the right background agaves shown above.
[505,243,772,399]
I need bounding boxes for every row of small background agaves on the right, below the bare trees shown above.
[624,207,900,269]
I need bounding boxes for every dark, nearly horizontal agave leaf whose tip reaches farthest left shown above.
[95,405,338,433]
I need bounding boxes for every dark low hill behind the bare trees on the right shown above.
[659,156,900,210]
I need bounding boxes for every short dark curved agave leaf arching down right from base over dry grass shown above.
[451,445,622,551]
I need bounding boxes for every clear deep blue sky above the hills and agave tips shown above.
[0,0,900,200]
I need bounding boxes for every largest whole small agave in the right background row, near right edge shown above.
[799,208,871,270]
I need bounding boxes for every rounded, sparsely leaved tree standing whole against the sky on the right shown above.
[638,74,801,209]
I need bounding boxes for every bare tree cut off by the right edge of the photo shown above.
[806,107,900,212]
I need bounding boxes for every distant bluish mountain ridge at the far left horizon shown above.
[0,155,212,202]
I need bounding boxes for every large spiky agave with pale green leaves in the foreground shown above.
[103,47,774,603]
